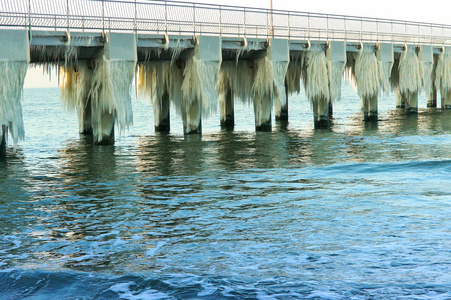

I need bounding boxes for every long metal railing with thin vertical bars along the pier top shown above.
[0,0,451,45]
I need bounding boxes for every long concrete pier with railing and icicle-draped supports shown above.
[0,0,451,155]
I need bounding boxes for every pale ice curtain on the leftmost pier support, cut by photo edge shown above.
[0,60,28,144]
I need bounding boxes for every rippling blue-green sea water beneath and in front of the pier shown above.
[0,83,451,300]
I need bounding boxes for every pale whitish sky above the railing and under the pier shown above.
[25,0,451,88]
